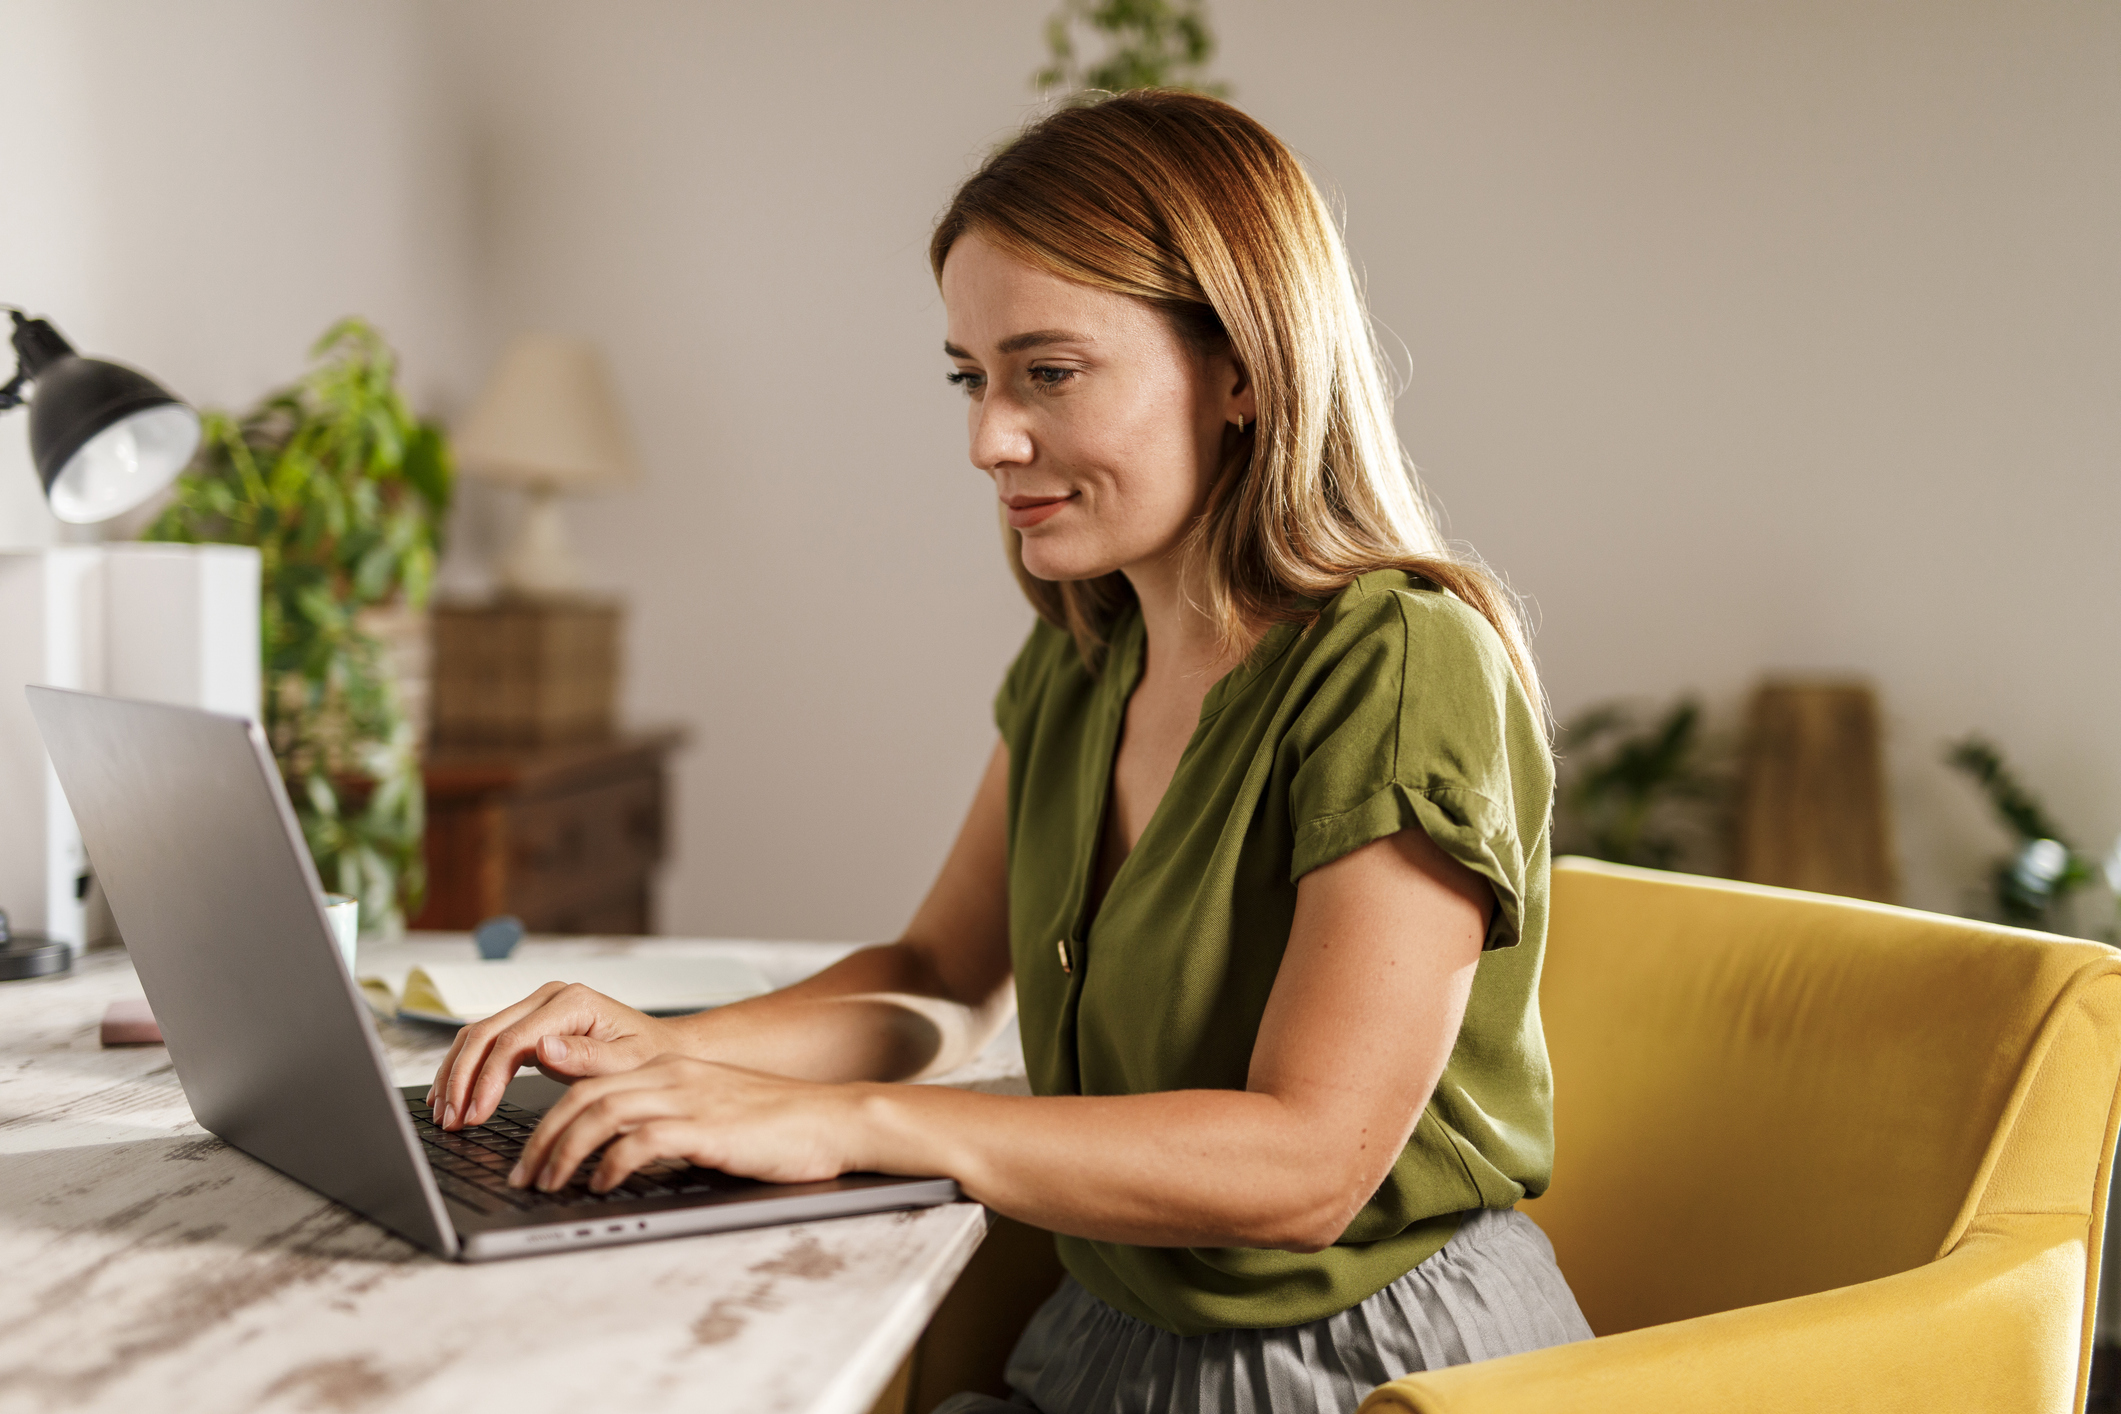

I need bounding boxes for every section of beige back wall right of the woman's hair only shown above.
[1222,0,2121,922]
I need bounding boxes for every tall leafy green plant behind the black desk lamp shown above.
[146,318,452,933]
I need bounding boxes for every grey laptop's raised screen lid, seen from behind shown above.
[28,687,456,1255]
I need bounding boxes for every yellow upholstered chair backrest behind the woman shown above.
[1525,861,2121,1336]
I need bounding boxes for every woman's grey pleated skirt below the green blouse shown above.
[935,1208,1591,1414]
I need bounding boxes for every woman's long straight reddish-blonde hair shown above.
[929,89,1546,723]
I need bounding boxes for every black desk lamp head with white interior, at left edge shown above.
[0,305,199,526]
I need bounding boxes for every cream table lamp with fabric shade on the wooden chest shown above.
[454,333,641,598]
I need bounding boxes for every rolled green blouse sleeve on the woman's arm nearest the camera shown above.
[1290,589,1555,948]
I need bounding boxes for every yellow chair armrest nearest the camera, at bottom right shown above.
[1360,1213,2089,1414]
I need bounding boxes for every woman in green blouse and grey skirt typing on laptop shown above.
[435,91,1589,1414]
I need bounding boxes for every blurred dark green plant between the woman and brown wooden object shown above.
[1555,697,1733,871]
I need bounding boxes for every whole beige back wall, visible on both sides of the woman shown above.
[448,0,2121,937]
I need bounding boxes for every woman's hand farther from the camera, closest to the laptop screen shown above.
[426,982,685,1130]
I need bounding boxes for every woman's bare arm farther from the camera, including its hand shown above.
[428,744,1016,1130]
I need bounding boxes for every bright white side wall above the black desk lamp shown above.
[0,0,475,545]
